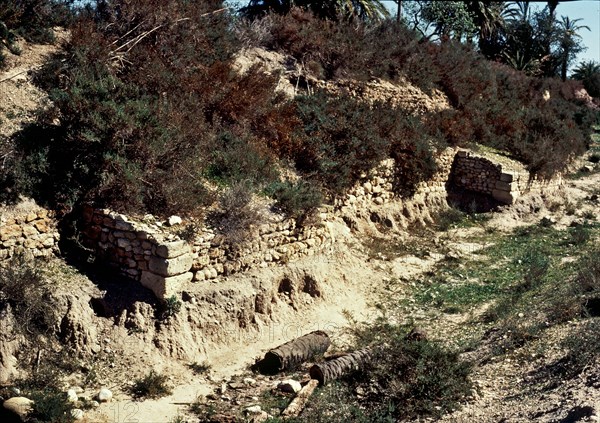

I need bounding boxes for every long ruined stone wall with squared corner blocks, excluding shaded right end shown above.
[83,149,455,299]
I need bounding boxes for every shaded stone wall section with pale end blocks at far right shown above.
[451,150,562,204]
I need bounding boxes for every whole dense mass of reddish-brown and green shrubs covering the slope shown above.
[1,0,592,219]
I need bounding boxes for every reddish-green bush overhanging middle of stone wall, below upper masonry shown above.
[293,92,435,197]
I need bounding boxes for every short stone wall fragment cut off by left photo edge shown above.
[0,209,59,260]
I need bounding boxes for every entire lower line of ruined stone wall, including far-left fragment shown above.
[0,148,560,299]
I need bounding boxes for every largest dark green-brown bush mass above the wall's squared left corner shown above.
[6,0,281,215]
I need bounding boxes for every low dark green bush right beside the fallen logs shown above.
[348,318,473,420]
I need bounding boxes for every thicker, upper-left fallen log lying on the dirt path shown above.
[254,330,331,374]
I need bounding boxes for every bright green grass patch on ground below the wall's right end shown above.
[414,223,600,320]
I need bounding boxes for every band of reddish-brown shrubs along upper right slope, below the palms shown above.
[244,10,593,177]
